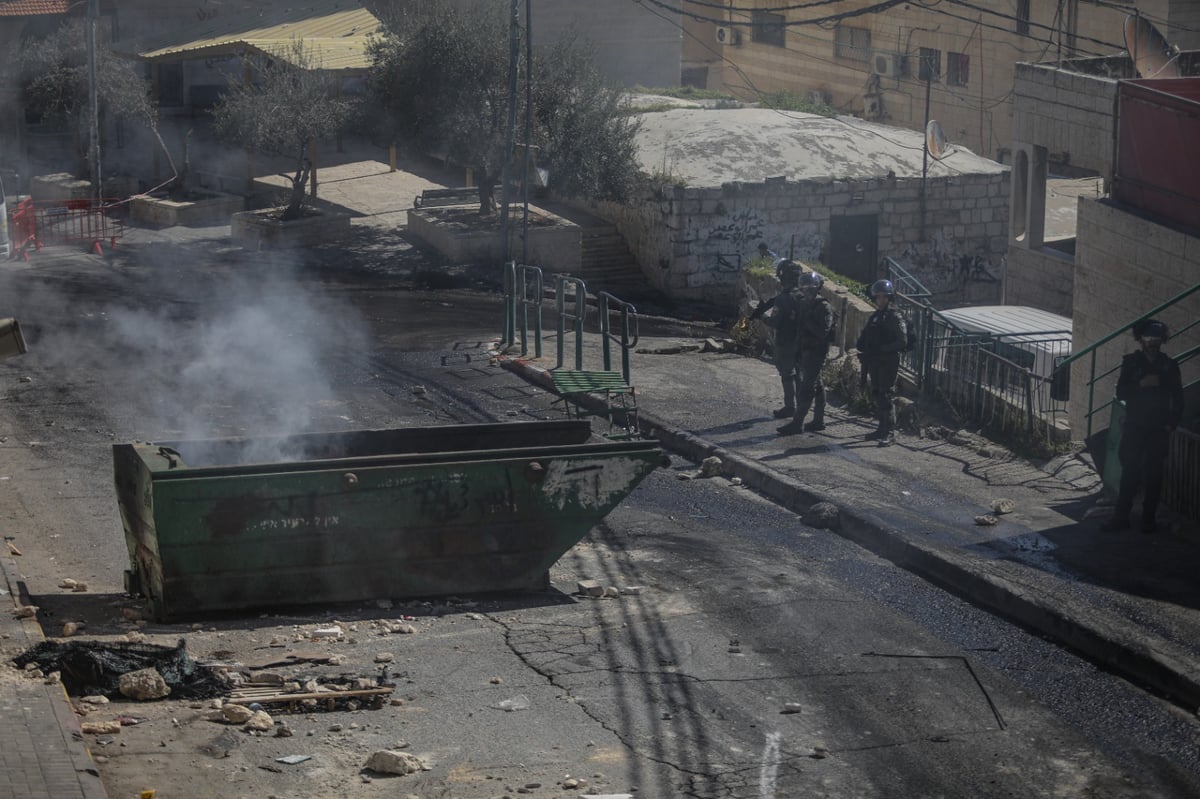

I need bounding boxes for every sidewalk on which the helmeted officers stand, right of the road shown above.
[489,328,1200,711]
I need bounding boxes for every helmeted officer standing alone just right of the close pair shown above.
[857,281,908,446]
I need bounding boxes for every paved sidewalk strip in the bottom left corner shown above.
[0,547,107,799]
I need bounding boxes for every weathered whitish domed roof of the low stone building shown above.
[637,108,1008,186]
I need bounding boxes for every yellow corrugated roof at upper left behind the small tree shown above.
[137,0,380,70]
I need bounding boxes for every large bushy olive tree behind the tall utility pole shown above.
[370,1,637,215]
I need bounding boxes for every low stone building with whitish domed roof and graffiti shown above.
[593,108,1009,310]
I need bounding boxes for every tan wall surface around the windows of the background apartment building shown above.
[684,0,1126,162]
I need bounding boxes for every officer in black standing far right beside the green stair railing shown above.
[1102,319,1183,533]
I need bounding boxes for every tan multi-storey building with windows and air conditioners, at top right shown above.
[668,0,1200,165]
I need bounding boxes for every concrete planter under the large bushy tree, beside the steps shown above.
[408,205,583,272]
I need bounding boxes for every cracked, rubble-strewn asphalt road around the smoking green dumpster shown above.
[0,237,1200,799]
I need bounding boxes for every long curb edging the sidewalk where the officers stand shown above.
[497,355,1200,711]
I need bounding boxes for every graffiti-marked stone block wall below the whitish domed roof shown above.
[595,172,1009,311]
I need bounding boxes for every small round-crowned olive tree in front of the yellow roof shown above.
[212,41,354,220]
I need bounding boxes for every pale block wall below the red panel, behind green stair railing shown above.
[1070,198,1200,438]
